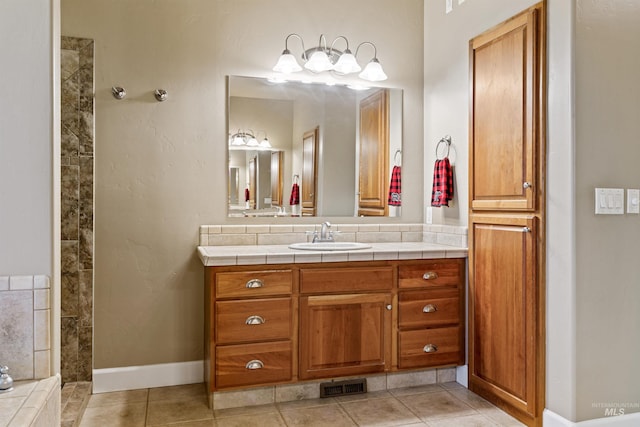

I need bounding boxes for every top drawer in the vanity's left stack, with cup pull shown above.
[215,270,293,298]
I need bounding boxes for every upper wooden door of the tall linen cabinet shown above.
[469,3,544,211]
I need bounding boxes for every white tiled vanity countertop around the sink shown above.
[198,242,467,267]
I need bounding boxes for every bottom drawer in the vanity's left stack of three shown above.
[215,341,292,389]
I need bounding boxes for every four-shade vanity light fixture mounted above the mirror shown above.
[273,33,387,82]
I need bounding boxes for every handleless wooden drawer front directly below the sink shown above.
[300,266,393,294]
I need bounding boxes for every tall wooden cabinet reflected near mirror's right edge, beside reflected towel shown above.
[358,89,389,216]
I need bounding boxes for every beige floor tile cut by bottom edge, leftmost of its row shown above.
[80,402,147,427]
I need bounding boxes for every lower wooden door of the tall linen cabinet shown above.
[469,215,543,417]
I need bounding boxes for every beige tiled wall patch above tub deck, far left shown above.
[0,276,51,381]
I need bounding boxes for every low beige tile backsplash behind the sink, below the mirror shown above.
[199,224,467,248]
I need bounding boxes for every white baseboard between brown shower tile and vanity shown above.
[93,360,204,393]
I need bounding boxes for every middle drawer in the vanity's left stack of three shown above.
[215,298,293,344]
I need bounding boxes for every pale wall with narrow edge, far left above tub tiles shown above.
[0,0,60,373]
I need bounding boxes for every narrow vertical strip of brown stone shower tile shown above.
[60,37,94,382]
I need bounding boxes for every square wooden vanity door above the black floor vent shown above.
[299,294,391,379]
